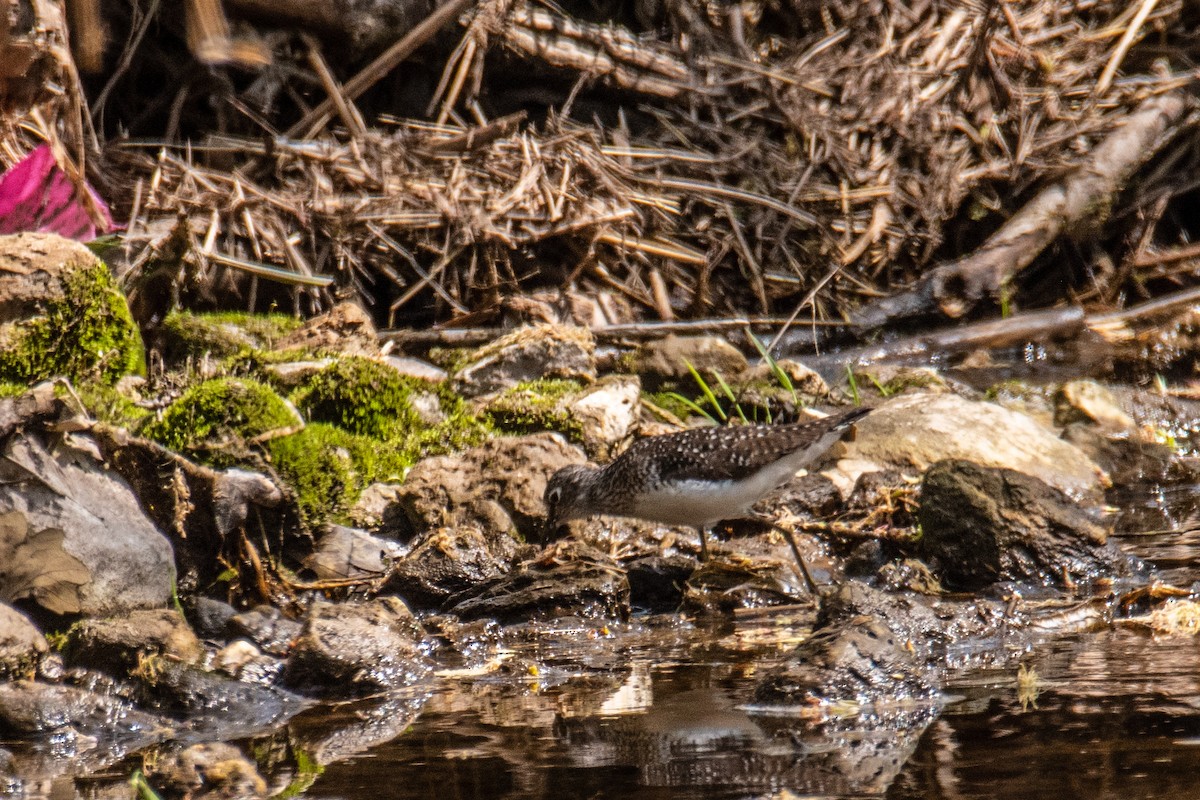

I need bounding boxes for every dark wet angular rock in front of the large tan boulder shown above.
[919,459,1138,590]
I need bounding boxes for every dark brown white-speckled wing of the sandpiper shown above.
[612,408,870,483]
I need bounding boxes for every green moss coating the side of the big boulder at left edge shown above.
[0,260,145,384]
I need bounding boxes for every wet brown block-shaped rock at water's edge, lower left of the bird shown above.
[283,597,432,697]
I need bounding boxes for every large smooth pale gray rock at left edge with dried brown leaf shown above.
[0,431,175,616]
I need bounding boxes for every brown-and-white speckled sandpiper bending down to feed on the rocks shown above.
[545,408,870,591]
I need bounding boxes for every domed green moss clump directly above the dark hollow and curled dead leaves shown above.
[142,378,299,467]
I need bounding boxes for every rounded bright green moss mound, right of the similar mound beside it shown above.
[294,357,420,439]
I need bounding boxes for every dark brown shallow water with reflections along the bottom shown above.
[285,488,1200,800]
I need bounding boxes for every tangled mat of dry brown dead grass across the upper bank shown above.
[9,0,1198,325]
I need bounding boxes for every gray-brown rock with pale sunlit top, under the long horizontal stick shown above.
[452,325,596,397]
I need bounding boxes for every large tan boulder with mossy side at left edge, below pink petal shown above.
[0,233,144,384]
